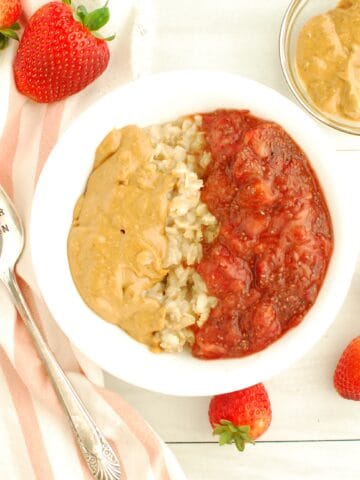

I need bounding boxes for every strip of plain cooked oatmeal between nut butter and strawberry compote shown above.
[147,116,217,352]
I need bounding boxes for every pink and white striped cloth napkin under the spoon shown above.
[0,0,185,480]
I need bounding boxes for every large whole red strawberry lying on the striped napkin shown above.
[14,0,113,103]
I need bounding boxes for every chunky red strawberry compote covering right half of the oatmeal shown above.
[192,110,333,359]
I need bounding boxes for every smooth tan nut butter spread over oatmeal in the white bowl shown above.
[68,126,174,349]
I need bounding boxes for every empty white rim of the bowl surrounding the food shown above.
[30,71,356,396]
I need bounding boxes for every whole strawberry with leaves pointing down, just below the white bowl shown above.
[209,383,271,452]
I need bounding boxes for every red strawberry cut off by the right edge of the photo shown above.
[334,337,360,400]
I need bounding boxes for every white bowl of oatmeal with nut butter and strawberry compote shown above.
[31,72,356,395]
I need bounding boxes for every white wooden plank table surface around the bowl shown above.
[106,0,360,480]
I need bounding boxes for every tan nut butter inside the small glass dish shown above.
[296,0,360,120]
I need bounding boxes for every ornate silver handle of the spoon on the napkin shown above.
[2,270,122,480]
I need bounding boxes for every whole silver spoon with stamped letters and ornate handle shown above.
[0,186,122,480]
